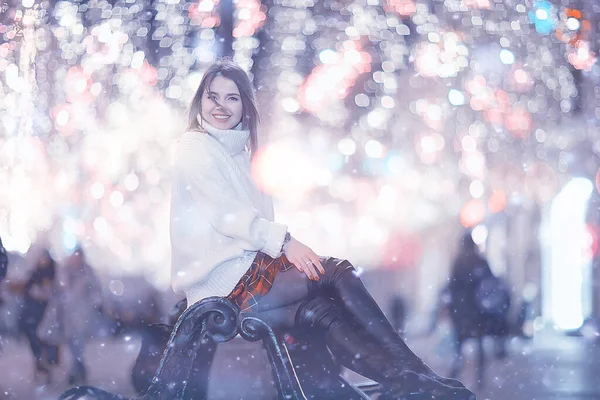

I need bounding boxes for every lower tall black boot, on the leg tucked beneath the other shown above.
[296,296,475,400]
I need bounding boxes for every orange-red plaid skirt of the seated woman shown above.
[227,253,294,311]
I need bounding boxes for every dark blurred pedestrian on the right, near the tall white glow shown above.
[448,232,510,386]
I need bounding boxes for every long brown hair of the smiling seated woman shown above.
[188,58,260,156]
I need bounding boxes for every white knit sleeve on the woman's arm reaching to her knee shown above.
[175,138,287,258]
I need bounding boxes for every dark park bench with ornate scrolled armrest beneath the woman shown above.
[61,297,379,400]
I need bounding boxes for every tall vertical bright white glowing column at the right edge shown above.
[546,178,594,329]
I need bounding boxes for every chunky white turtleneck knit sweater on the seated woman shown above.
[170,122,287,307]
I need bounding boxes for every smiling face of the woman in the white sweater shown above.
[202,75,243,129]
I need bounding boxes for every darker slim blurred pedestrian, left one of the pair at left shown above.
[19,249,56,382]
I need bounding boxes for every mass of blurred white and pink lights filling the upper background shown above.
[0,0,600,292]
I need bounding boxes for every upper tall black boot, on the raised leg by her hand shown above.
[309,258,464,388]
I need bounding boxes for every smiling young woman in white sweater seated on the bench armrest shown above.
[171,60,474,400]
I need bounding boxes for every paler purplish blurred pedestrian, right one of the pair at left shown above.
[61,247,103,385]
